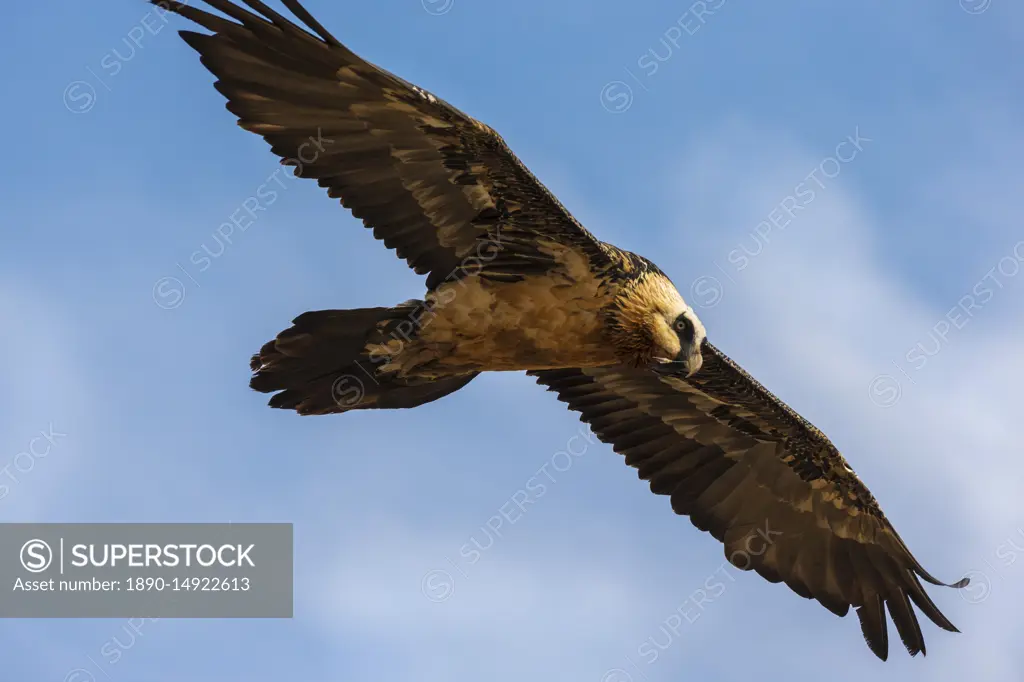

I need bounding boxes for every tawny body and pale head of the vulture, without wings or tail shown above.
[367,244,695,378]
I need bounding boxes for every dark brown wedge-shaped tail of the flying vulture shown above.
[249,301,477,415]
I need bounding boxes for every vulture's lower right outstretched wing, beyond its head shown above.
[529,341,967,659]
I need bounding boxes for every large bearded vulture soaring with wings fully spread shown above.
[151,0,966,659]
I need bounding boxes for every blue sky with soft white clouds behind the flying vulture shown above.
[0,0,1024,682]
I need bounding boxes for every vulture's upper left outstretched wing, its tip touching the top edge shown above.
[151,0,607,289]
